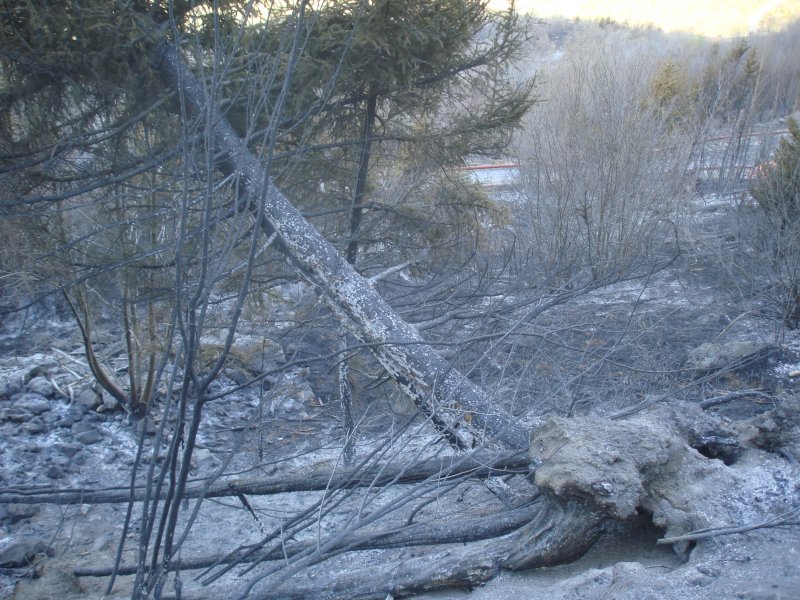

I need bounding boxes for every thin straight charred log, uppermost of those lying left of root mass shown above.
[0,452,529,505]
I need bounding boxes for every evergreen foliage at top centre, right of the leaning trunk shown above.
[232,0,531,262]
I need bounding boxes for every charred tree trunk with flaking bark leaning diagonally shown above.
[155,42,528,449]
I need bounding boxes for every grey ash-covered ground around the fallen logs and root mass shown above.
[0,191,800,600]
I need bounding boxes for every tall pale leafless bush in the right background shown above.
[517,31,688,288]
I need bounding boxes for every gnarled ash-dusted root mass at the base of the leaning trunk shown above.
[531,402,797,564]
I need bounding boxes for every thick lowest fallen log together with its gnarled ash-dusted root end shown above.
[169,402,800,600]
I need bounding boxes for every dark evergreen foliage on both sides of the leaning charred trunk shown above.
[0,0,530,412]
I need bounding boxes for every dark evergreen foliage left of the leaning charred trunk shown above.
[0,0,286,413]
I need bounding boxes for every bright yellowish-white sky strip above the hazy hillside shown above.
[490,0,800,37]
